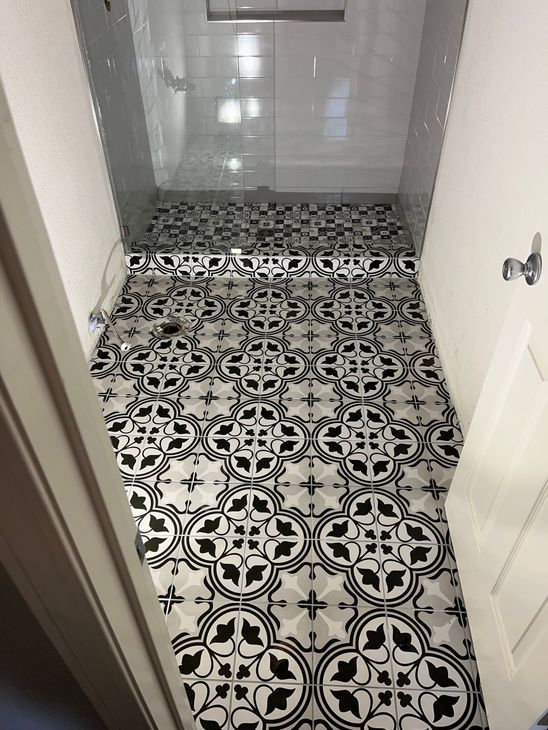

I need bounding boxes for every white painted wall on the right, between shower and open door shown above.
[421,0,548,429]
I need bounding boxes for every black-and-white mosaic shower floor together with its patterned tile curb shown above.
[127,201,418,279]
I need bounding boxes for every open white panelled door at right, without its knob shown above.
[447,268,548,730]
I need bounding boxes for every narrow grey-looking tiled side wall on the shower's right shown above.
[399,0,467,253]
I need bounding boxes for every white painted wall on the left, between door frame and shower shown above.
[0,0,125,356]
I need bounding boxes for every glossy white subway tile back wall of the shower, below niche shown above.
[128,0,426,200]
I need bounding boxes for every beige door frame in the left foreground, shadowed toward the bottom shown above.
[0,77,195,730]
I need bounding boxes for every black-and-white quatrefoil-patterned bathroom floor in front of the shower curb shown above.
[91,275,487,730]
